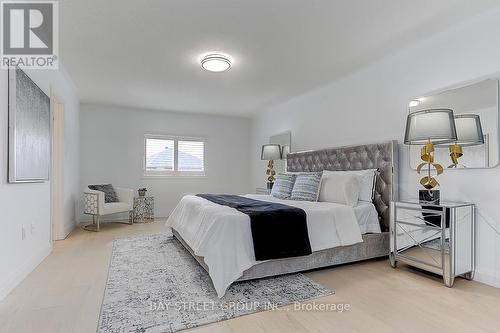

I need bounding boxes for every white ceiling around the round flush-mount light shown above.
[59,0,499,116]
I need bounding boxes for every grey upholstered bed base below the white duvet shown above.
[172,229,389,281]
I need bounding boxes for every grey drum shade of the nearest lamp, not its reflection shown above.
[405,109,457,145]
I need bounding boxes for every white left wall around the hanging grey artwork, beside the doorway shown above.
[0,67,79,299]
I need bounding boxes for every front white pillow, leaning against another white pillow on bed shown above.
[318,171,363,207]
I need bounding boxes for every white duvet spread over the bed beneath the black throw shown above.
[167,194,363,297]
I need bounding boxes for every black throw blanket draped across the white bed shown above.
[197,194,312,260]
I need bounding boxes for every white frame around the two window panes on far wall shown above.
[142,134,207,178]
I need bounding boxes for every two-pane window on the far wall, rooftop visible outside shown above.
[144,135,205,176]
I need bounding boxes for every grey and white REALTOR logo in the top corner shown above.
[1,1,58,69]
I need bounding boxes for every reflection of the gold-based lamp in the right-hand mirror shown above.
[438,114,484,168]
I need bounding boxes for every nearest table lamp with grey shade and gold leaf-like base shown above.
[404,109,457,192]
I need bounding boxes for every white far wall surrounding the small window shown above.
[81,104,251,219]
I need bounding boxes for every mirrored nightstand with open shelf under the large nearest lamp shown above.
[390,200,475,287]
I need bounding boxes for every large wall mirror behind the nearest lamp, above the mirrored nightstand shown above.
[408,79,500,169]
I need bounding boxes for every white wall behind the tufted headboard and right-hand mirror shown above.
[250,10,500,287]
